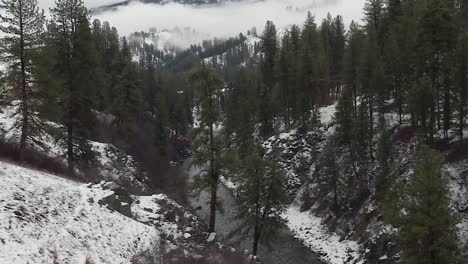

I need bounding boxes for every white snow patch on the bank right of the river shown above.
[283,205,359,264]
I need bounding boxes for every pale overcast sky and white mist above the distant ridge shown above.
[39,0,365,47]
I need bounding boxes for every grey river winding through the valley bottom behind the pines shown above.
[174,159,321,264]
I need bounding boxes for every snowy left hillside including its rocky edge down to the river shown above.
[0,161,244,264]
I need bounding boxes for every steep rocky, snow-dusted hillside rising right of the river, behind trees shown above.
[264,102,468,263]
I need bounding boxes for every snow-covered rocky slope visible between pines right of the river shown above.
[264,102,468,264]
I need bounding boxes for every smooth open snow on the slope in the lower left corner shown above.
[0,162,159,264]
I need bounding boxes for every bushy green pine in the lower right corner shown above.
[401,146,458,264]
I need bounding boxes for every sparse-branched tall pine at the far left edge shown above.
[0,0,45,162]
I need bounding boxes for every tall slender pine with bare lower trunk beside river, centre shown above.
[190,64,223,232]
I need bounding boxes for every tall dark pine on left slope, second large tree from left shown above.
[49,0,97,170]
